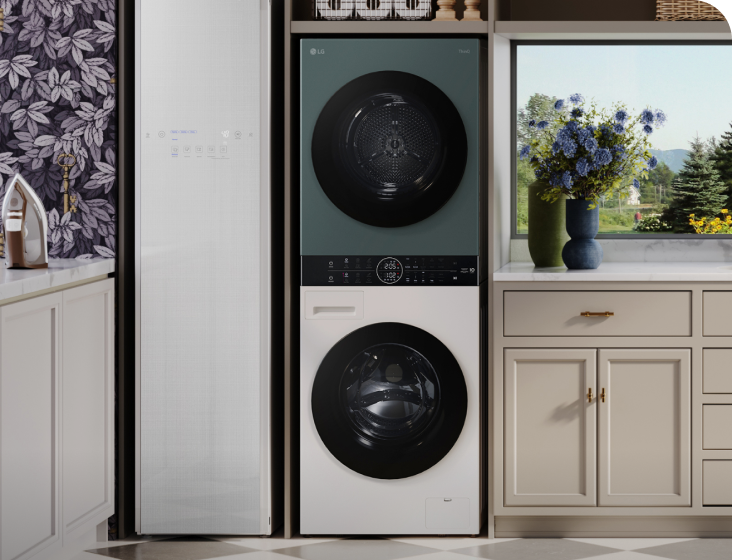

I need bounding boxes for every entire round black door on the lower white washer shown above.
[312,323,468,479]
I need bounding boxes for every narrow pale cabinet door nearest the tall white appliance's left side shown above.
[61,280,114,538]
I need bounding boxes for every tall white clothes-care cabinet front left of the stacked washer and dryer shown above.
[137,0,269,534]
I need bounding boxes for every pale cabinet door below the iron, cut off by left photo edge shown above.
[0,293,61,560]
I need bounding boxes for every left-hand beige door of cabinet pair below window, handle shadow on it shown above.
[504,349,597,506]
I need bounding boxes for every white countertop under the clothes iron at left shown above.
[0,258,114,303]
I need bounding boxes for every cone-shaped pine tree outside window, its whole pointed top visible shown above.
[663,137,727,233]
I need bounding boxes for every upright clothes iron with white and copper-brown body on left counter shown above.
[2,173,48,268]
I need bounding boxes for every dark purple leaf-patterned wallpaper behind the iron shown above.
[0,0,117,259]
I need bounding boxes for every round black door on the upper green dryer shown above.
[312,72,468,227]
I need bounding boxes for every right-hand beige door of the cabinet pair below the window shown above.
[598,348,691,506]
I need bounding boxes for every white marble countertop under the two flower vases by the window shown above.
[493,262,732,282]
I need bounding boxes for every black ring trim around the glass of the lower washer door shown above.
[311,323,468,479]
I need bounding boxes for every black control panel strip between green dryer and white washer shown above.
[301,256,478,286]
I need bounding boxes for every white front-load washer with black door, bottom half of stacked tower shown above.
[300,285,481,535]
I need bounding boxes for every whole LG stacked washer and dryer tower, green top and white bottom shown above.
[300,39,485,535]
